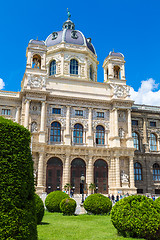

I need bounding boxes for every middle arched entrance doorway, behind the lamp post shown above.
[71,158,86,193]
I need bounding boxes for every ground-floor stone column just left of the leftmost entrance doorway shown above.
[37,153,44,192]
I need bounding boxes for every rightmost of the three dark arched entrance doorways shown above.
[94,159,108,194]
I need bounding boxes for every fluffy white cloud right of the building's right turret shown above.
[130,78,160,106]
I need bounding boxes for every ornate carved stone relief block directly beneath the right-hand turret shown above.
[110,84,130,98]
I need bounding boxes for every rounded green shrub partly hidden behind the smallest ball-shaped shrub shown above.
[45,191,69,212]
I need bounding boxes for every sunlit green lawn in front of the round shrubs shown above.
[38,211,145,240]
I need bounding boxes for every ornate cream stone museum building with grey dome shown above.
[0,16,160,194]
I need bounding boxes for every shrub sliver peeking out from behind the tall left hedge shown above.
[35,194,44,224]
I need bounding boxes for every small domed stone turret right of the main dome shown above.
[103,50,126,84]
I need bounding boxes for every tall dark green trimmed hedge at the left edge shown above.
[0,117,37,240]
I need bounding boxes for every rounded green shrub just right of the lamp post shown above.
[83,193,112,214]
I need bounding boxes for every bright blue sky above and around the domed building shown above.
[0,0,160,104]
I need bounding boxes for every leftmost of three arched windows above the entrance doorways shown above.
[50,122,61,142]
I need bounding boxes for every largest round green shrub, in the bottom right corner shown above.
[111,195,160,240]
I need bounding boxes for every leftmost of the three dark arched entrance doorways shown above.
[46,157,63,193]
